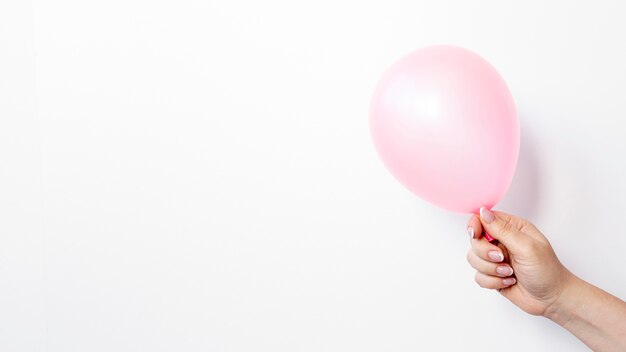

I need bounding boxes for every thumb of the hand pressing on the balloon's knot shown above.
[480,207,523,249]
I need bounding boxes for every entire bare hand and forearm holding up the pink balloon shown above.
[467,208,626,352]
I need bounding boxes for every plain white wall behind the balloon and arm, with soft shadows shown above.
[0,0,626,352]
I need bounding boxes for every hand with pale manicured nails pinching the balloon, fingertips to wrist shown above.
[467,208,575,316]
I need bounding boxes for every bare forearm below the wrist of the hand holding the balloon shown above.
[546,275,626,352]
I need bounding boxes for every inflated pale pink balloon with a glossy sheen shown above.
[370,46,520,213]
